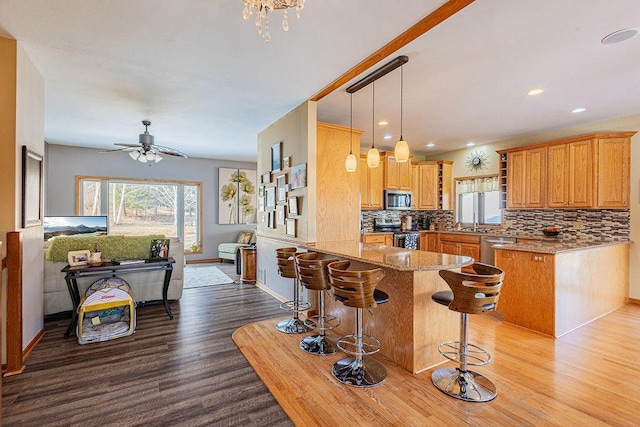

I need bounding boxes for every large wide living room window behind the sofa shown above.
[76,177,202,248]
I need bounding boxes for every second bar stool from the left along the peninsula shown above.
[296,252,340,354]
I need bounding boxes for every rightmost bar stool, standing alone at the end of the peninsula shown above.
[431,263,504,402]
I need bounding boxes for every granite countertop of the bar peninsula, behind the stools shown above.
[304,241,473,271]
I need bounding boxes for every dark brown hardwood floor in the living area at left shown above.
[2,263,291,426]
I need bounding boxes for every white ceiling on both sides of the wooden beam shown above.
[0,0,640,161]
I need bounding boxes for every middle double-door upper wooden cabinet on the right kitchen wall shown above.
[547,139,594,208]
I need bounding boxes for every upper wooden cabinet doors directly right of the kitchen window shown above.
[507,147,547,209]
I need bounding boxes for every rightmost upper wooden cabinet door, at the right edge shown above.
[596,133,634,209]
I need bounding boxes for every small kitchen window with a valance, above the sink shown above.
[456,175,502,225]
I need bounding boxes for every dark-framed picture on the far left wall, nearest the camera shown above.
[22,145,44,228]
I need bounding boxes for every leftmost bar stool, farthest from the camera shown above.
[276,248,311,334]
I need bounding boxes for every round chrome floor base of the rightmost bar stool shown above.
[431,368,498,402]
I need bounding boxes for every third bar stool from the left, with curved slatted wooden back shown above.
[327,261,389,387]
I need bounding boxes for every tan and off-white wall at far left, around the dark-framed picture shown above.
[0,38,44,362]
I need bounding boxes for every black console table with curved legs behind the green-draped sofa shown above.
[62,257,176,338]
